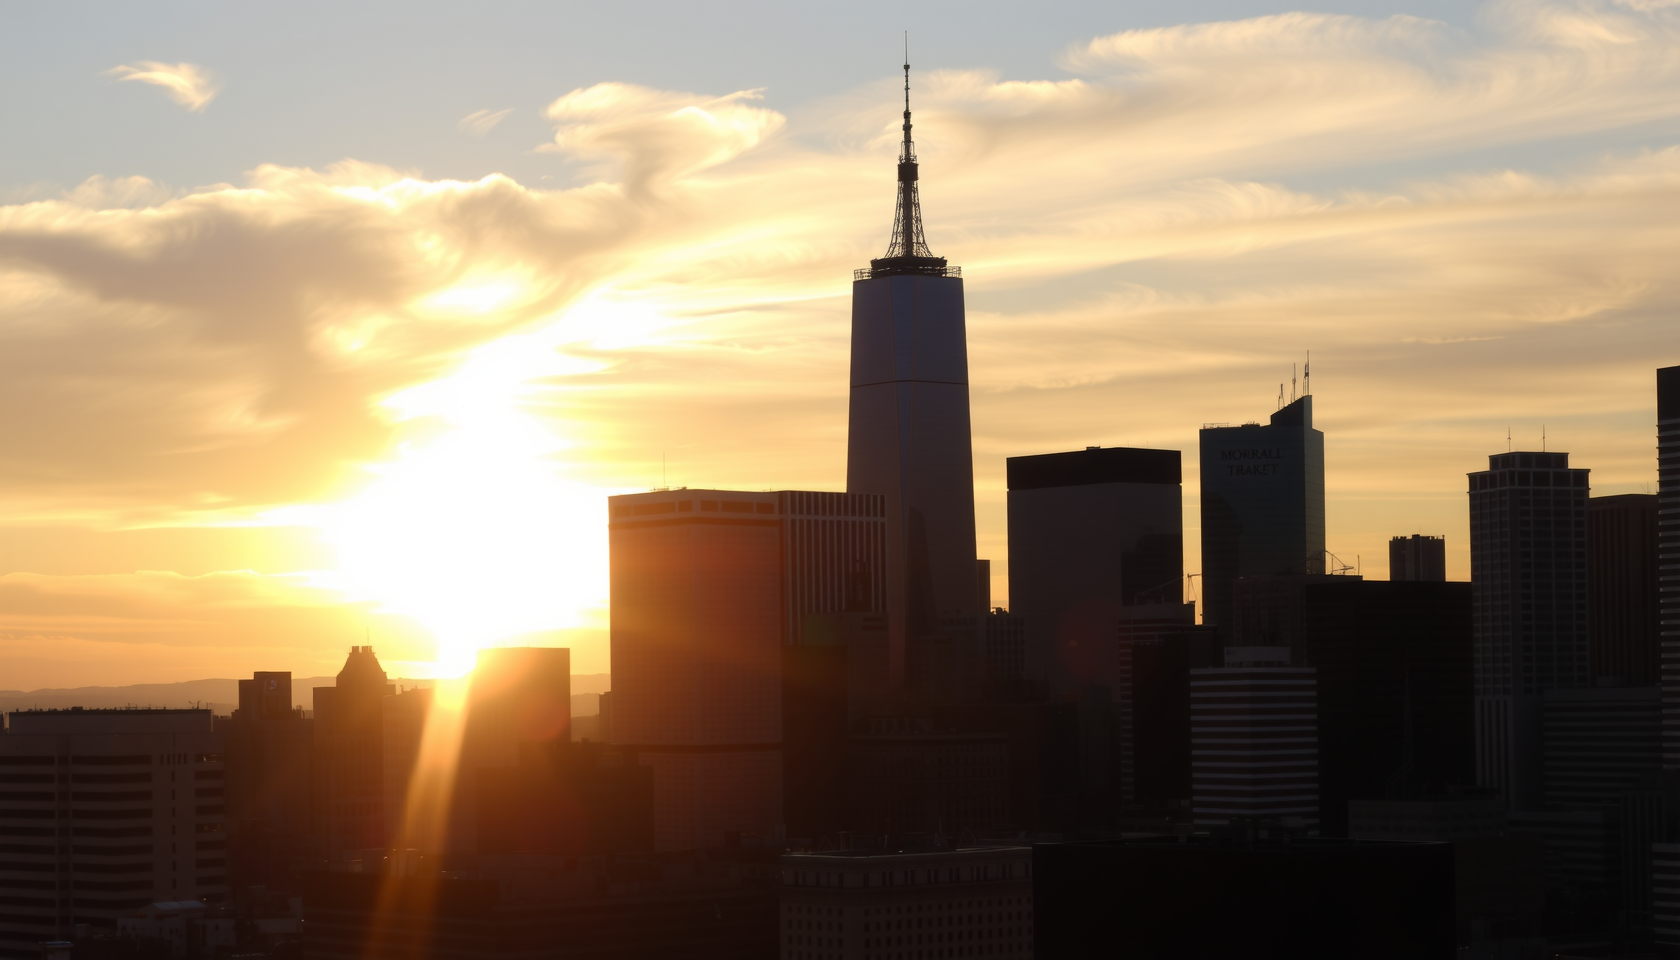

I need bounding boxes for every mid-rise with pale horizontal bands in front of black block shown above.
[1189,659,1319,832]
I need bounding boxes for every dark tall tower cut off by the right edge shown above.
[1656,367,1680,766]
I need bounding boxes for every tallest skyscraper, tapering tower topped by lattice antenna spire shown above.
[845,64,981,689]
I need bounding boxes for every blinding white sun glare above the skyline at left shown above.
[277,307,606,678]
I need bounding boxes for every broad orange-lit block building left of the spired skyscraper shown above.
[608,489,893,851]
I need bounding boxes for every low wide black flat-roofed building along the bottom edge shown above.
[1033,834,1455,960]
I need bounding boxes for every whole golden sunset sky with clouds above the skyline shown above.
[0,0,1680,689]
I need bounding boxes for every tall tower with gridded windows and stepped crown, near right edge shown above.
[1470,451,1593,810]
